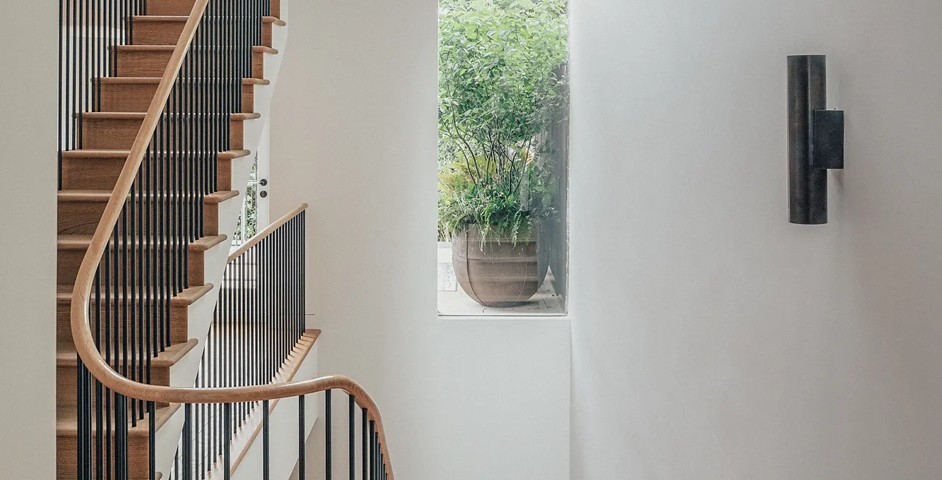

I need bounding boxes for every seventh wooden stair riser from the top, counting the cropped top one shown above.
[58,197,225,238]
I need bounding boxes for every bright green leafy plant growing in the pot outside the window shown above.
[439,0,568,241]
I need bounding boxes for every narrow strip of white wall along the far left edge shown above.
[0,1,58,479]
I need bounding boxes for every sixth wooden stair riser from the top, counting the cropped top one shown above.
[60,157,232,190]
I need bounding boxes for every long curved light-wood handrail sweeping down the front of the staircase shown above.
[65,0,395,480]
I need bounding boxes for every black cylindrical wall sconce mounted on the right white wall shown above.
[788,55,844,225]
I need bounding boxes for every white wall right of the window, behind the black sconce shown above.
[571,0,942,480]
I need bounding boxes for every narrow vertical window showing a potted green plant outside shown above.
[438,0,569,315]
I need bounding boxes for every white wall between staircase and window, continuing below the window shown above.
[271,0,570,480]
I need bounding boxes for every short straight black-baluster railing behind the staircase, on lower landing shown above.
[170,206,305,479]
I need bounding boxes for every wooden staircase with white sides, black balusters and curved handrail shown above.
[56,0,392,480]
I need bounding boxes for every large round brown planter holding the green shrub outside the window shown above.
[451,225,546,307]
